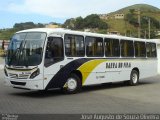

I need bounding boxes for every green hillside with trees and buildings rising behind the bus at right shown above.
[63,4,160,38]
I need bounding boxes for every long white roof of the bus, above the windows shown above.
[17,28,154,42]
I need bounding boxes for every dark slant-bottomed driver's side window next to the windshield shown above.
[45,37,64,67]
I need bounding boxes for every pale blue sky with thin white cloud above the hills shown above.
[0,0,160,29]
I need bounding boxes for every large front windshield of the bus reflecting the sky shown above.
[6,32,46,67]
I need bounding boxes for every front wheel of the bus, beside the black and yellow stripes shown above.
[63,74,82,94]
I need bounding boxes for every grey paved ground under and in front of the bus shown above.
[0,67,160,114]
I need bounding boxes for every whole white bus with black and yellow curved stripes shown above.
[4,28,157,93]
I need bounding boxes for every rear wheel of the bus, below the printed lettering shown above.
[128,70,139,86]
